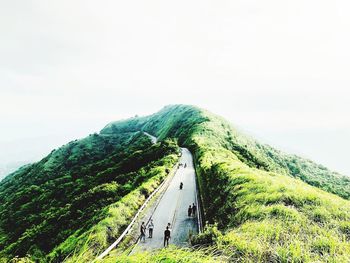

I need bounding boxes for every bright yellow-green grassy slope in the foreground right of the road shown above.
[193,150,350,262]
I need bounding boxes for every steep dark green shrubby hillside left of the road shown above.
[0,132,178,262]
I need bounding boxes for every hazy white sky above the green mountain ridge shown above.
[0,0,350,175]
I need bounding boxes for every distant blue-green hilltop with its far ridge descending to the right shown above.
[102,105,350,199]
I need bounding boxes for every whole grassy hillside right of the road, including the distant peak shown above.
[103,105,350,262]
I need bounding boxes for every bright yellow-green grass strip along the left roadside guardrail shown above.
[53,155,178,262]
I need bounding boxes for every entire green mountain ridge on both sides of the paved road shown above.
[0,105,350,262]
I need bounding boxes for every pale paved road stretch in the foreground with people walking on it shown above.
[133,148,198,252]
